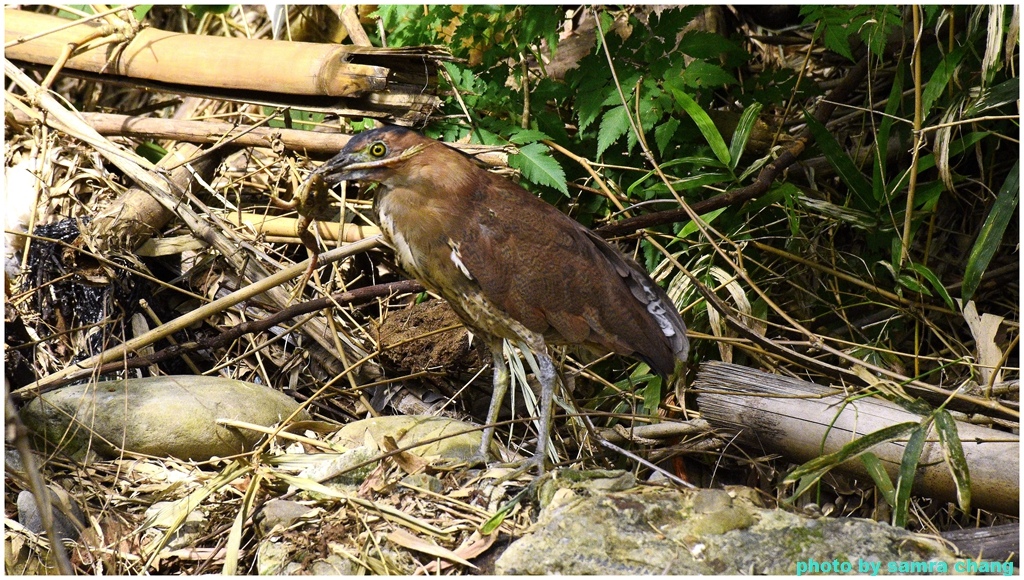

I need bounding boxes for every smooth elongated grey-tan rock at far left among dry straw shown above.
[20,376,309,461]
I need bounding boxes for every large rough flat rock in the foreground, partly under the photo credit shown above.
[495,473,953,575]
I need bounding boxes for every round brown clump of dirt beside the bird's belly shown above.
[377,300,485,374]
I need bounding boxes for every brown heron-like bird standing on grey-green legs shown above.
[312,126,689,472]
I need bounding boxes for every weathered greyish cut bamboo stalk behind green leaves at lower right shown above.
[693,362,1020,515]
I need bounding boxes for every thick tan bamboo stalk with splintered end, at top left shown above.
[4,9,455,125]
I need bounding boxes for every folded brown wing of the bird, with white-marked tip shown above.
[458,174,687,375]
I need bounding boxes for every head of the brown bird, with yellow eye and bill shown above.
[310,126,434,184]
